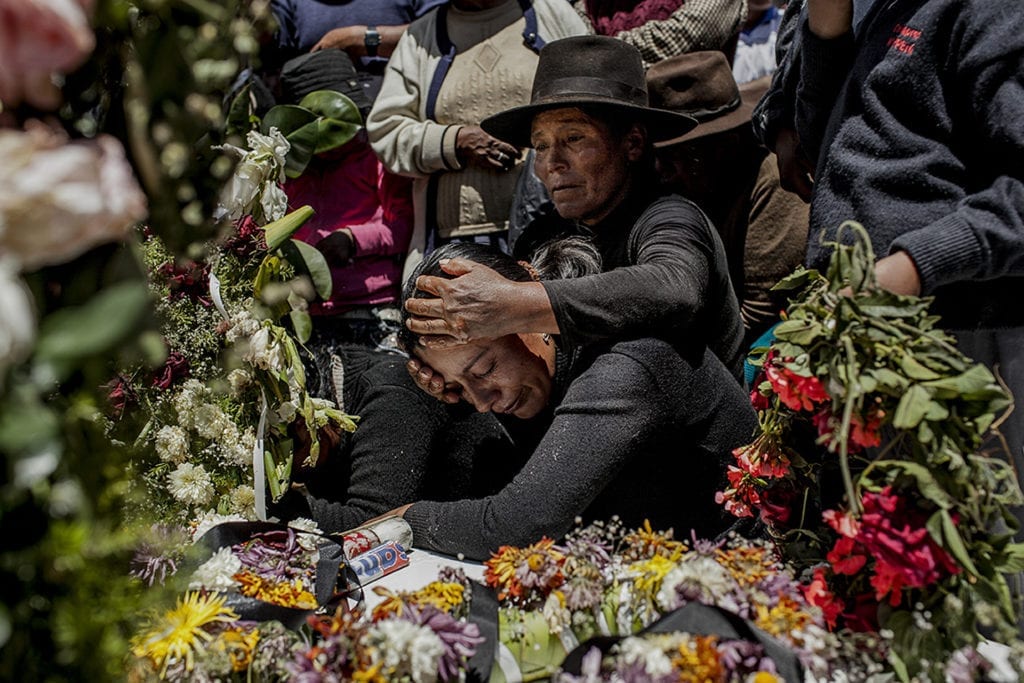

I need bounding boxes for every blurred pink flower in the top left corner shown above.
[0,0,95,111]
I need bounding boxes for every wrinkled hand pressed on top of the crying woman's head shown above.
[406,258,523,348]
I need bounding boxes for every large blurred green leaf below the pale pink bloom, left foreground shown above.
[36,282,150,362]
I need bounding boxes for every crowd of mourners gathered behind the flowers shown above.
[263,0,1024,559]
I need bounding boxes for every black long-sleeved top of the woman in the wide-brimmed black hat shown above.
[536,182,743,379]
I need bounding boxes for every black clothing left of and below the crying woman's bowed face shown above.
[279,345,522,533]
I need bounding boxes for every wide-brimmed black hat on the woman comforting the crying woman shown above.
[480,36,696,147]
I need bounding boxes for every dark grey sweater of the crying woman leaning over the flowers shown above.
[406,338,757,559]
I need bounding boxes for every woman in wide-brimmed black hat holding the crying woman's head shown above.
[406,36,743,401]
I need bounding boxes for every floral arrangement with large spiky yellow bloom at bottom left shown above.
[130,520,482,683]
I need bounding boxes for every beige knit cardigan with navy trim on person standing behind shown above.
[367,0,586,276]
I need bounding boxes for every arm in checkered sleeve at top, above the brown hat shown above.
[615,0,746,67]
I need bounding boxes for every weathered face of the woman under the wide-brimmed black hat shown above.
[530,109,644,224]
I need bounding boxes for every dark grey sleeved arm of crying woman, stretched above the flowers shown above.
[404,352,671,560]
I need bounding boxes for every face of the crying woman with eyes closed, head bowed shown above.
[415,335,554,420]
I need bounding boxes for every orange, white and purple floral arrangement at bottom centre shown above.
[375,520,880,683]
